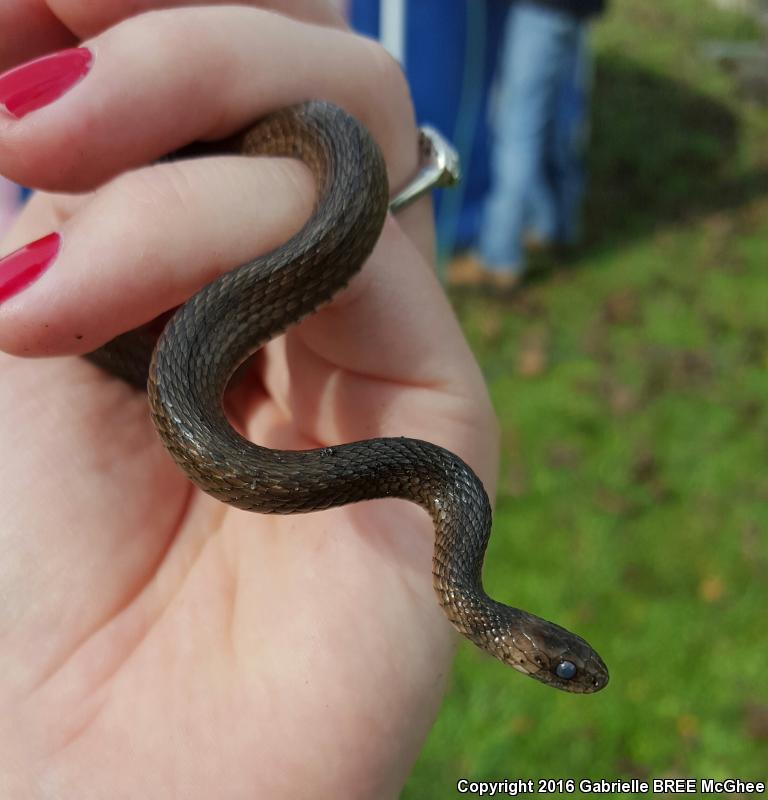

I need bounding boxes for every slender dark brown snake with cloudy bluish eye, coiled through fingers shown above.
[90,100,608,693]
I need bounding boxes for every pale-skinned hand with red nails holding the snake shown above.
[0,0,496,800]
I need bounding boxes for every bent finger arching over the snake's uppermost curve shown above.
[0,6,417,191]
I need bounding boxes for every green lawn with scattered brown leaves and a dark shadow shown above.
[403,0,768,800]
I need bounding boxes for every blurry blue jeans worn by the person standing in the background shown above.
[479,0,589,273]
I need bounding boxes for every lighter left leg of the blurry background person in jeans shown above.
[480,2,573,273]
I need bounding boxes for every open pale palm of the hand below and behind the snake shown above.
[0,322,451,798]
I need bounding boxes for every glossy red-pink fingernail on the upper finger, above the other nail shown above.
[0,47,93,119]
